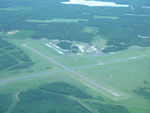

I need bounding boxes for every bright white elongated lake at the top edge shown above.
[61,0,129,7]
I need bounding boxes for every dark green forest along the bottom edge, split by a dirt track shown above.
[12,82,130,113]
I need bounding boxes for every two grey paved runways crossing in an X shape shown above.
[0,44,146,97]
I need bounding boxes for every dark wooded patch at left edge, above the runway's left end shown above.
[0,39,33,71]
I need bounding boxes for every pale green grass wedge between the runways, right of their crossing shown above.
[79,56,150,93]
